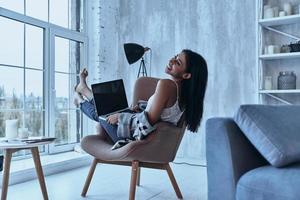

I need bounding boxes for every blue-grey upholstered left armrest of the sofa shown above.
[206,118,267,200]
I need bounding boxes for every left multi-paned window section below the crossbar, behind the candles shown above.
[0,17,45,137]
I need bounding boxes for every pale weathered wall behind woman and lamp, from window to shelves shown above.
[89,0,257,159]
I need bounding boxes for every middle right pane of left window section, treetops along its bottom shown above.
[25,69,43,110]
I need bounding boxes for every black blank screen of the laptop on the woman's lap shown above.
[92,79,128,116]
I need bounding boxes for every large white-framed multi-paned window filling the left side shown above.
[0,0,87,155]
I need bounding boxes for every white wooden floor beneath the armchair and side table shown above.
[7,164,207,200]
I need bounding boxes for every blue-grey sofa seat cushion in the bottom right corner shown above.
[236,163,300,200]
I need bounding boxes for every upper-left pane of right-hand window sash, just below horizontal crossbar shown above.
[55,37,70,73]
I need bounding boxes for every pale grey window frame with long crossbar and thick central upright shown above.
[0,1,88,154]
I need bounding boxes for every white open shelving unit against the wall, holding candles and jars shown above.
[256,0,300,104]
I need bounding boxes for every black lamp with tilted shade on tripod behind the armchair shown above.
[124,43,150,78]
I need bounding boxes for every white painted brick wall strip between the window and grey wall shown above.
[85,0,123,134]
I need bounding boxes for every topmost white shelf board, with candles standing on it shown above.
[258,15,300,26]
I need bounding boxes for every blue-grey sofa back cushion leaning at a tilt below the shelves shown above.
[234,105,300,167]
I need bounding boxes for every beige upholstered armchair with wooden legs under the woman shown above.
[81,77,186,200]
